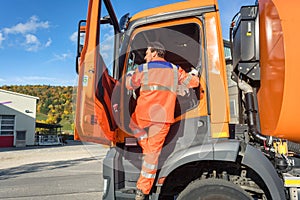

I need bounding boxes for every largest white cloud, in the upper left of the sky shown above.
[3,16,50,34]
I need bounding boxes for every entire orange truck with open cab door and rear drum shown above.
[75,0,300,200]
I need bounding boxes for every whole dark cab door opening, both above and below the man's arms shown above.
[127,23,203,116]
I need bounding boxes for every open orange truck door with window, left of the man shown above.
[74,0,120,145]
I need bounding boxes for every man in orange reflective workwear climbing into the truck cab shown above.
[126,42,199,200]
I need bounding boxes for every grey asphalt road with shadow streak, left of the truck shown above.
[0,143,108,200]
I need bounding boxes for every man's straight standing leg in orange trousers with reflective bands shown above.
[137,123,170,194]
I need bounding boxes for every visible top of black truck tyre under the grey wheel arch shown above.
[177,179,252,200]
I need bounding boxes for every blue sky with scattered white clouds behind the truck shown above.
[0,0,255,86]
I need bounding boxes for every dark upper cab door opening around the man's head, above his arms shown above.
[128,23,201,71]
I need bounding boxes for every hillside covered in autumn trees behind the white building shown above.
[0,85,74,133]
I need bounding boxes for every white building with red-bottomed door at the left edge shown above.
[0,89,39,147]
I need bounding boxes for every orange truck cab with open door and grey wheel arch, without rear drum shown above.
[75,0,300,200]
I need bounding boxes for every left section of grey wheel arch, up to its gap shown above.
[154,140,239,199]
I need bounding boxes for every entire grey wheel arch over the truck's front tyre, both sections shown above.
[156,141,286,199]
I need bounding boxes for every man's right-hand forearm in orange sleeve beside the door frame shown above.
[178,67,199,88]
